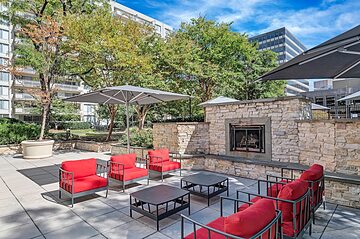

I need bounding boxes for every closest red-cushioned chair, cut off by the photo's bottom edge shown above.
[181,197,282,239]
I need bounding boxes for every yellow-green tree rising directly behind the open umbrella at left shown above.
[64,9,154,140]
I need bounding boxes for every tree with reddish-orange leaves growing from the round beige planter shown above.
[0,0,106,140]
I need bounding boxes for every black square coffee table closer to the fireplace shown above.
[180,173,229,206]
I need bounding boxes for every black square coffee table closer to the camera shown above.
[130,185,190,231]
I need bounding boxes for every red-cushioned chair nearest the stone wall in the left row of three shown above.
[147,149,181,181]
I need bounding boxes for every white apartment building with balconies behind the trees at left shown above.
[0,1,172,122]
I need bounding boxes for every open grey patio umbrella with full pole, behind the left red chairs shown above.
[65,85,191,152]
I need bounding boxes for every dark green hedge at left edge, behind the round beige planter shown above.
[0,118,40,144]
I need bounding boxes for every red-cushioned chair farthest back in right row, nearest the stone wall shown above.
[267,164,325,223]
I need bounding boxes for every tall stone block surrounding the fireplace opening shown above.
[205,97,310,163]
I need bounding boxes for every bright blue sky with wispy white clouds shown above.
[117,0,360,48]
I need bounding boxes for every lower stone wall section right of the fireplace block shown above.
[298,119,360,176]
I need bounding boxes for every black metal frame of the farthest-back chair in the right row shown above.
[266,168,326,224]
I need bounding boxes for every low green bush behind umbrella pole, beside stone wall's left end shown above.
[119,127,153,148]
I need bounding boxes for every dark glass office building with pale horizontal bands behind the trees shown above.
[249,27,309,96]
